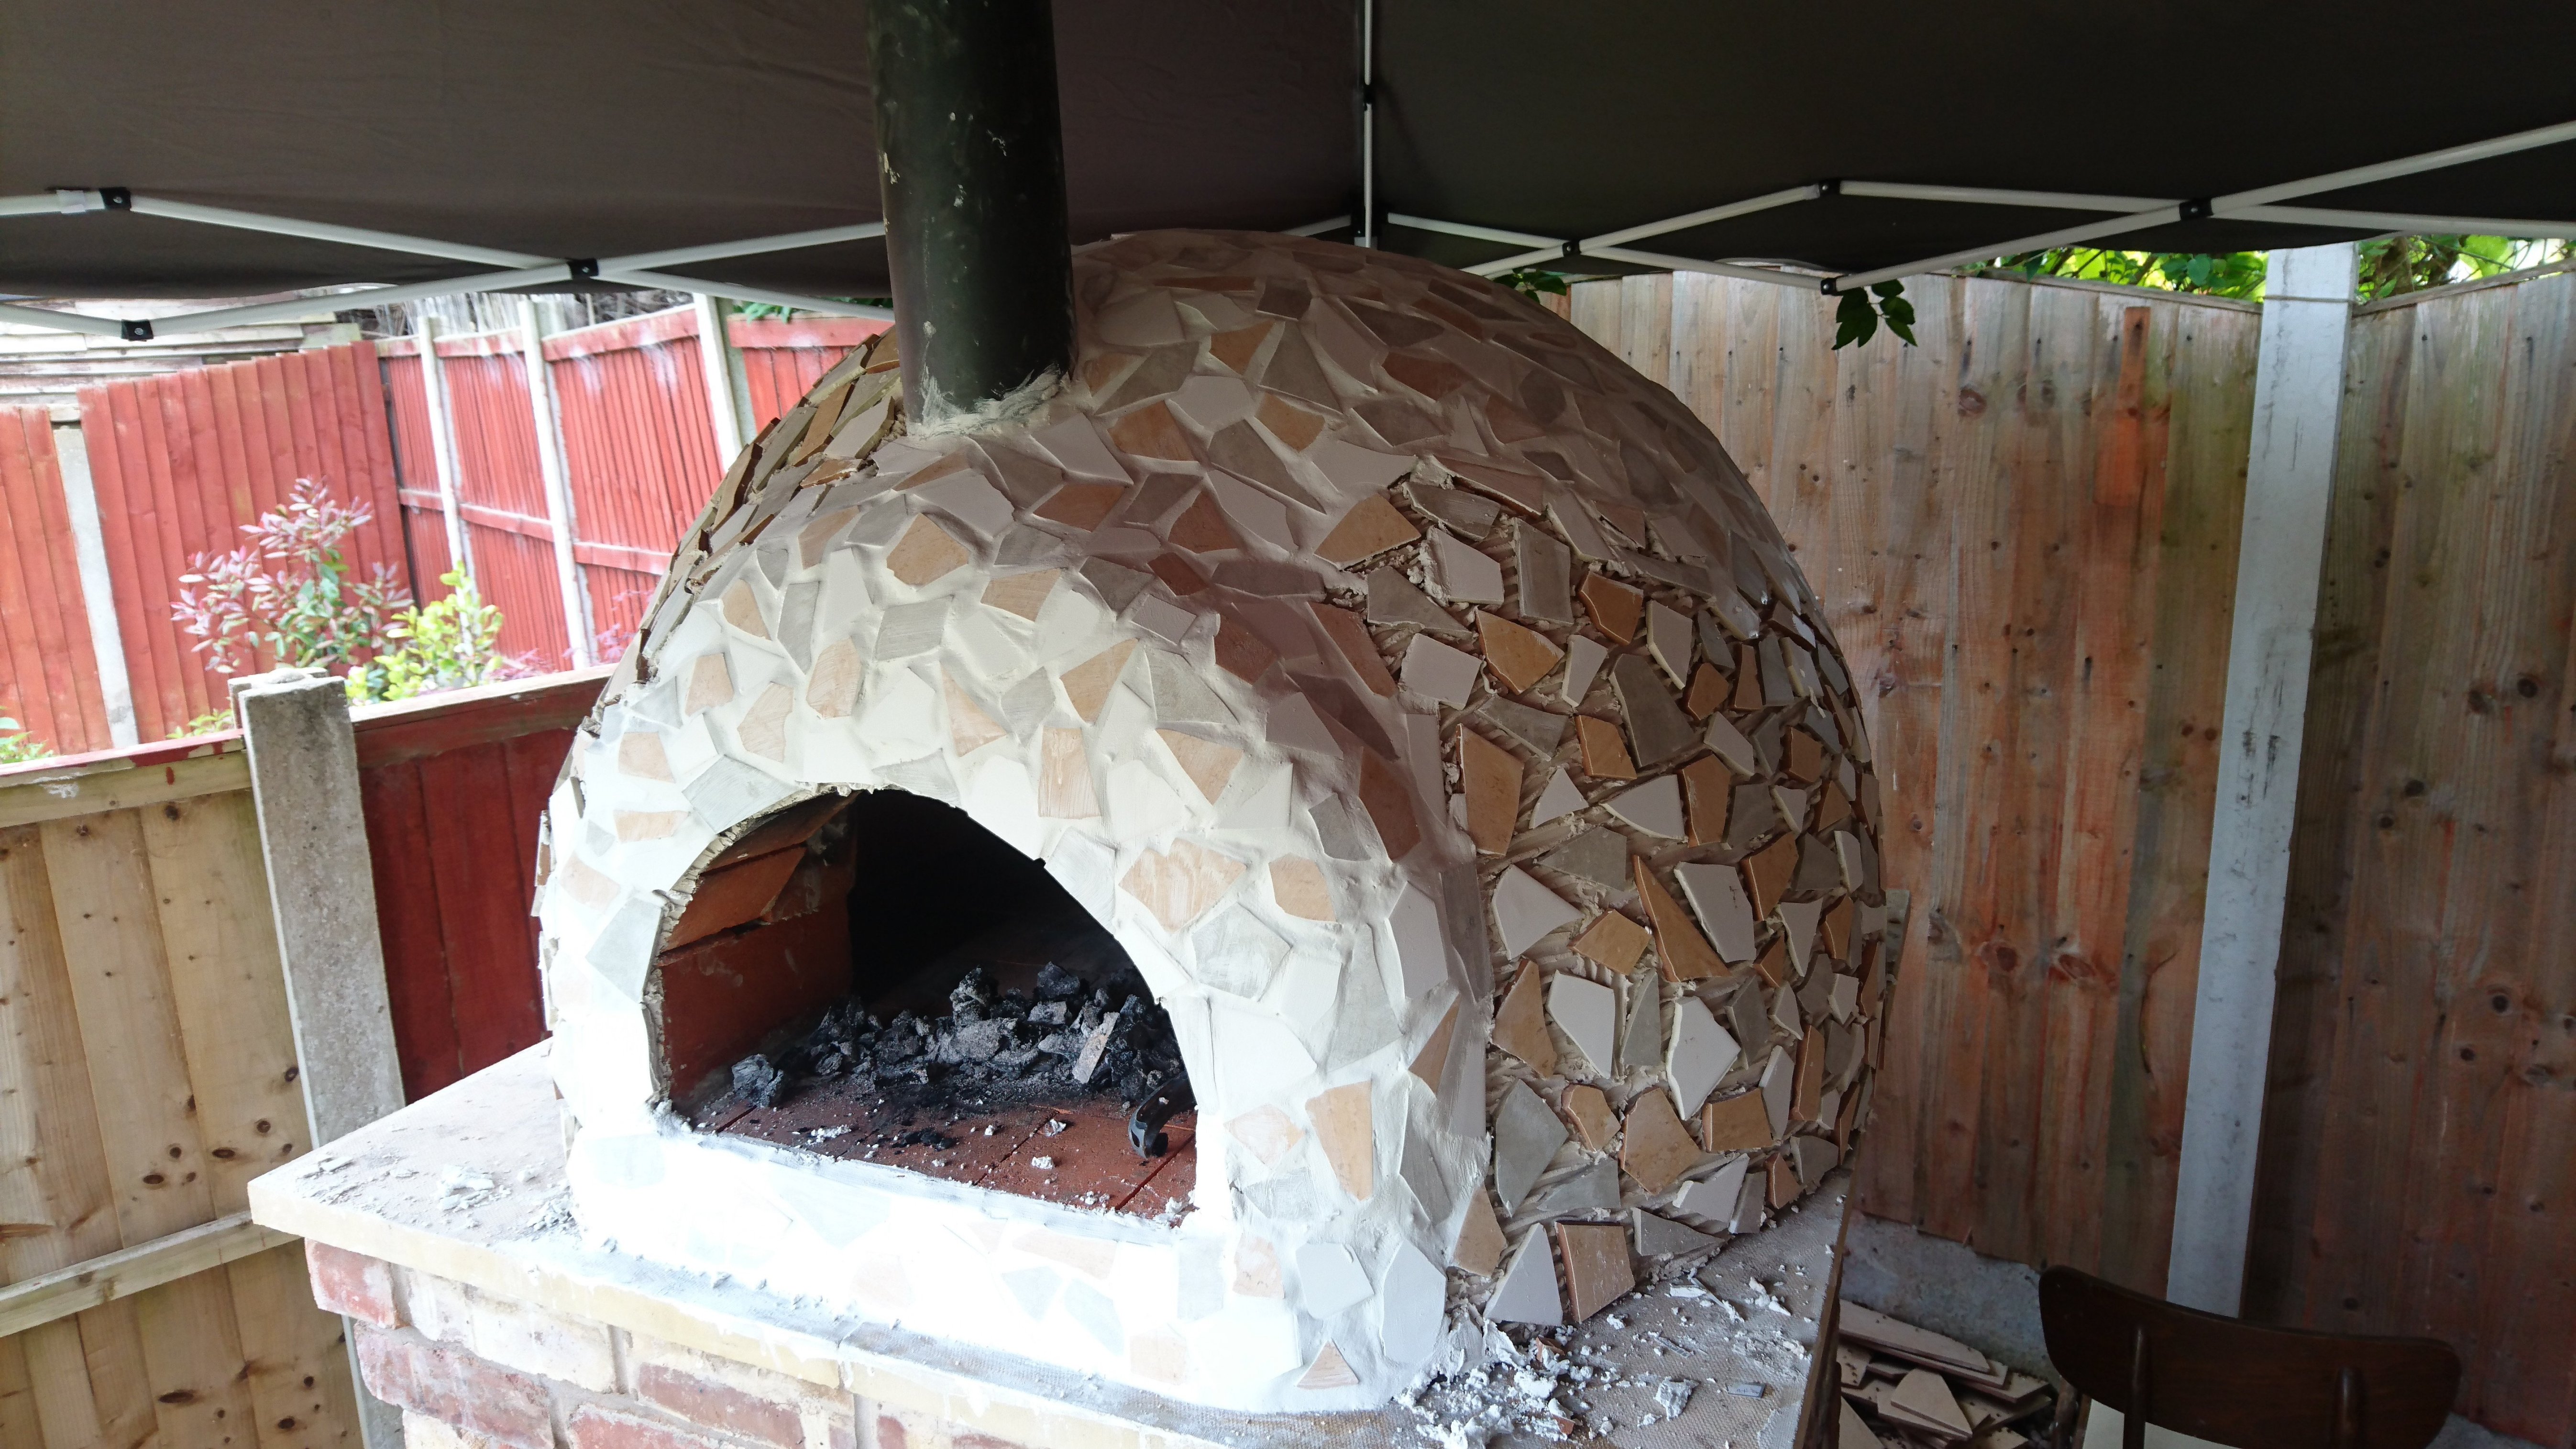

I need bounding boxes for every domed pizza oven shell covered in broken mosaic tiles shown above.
[541,232,1888,1410]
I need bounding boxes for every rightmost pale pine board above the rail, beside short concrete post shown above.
[142,789,312,1215]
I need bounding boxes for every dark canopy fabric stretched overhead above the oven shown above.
[0,0,2576,297]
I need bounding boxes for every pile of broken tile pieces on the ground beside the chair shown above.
[1834,1299,2058,1449]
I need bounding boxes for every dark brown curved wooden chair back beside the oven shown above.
[2040,1269,2460,1449]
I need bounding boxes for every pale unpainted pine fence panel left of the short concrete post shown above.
[0,742,358,1449]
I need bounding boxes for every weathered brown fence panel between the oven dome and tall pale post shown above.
[1566,276,2259,1286]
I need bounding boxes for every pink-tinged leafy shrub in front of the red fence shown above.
[170,477,412,696]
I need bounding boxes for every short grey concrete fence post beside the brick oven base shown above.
[232,670,402,1449]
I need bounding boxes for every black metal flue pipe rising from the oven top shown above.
[868,0,1074,428]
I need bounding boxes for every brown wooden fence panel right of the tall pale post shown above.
[2246,265,2576,1444]
